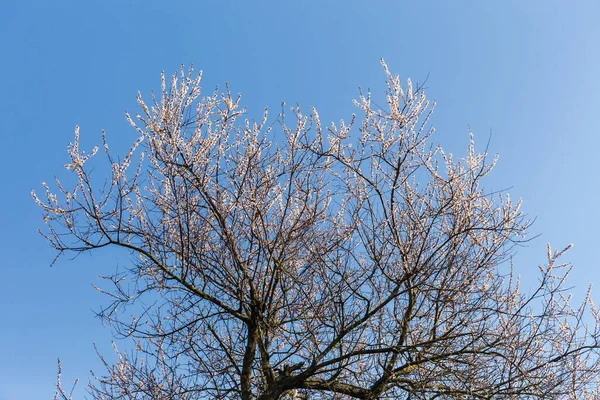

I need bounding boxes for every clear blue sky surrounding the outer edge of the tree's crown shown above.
[0,0,600,400]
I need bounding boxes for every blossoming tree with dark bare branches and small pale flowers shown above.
[33,62,600,400]
